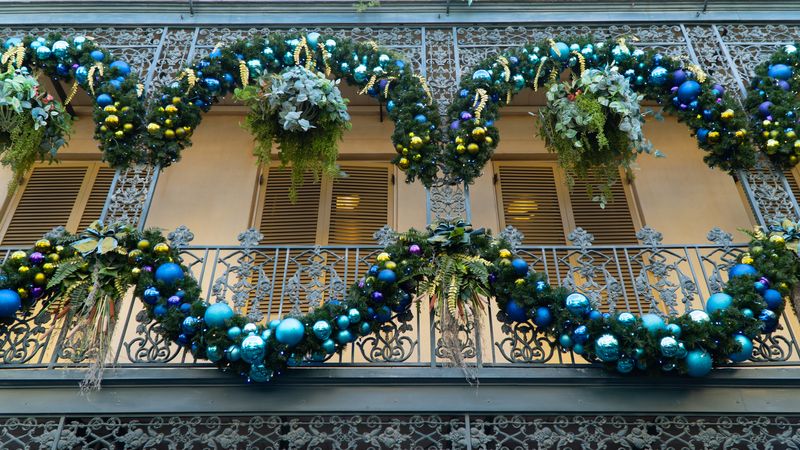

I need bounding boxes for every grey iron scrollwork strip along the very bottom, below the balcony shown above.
[0,414,800,450]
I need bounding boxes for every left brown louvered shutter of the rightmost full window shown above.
[497,164,566,245]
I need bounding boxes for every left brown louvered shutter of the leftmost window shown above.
[1,166,88,247]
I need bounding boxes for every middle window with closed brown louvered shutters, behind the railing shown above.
[247,162,394,319]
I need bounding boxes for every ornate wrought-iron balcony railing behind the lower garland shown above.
[0,223,800,377]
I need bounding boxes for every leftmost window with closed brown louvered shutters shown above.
[0,161,114,246]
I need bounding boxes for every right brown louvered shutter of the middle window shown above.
[328,165,391,245]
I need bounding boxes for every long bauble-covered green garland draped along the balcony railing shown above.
[0,218,800,382]
